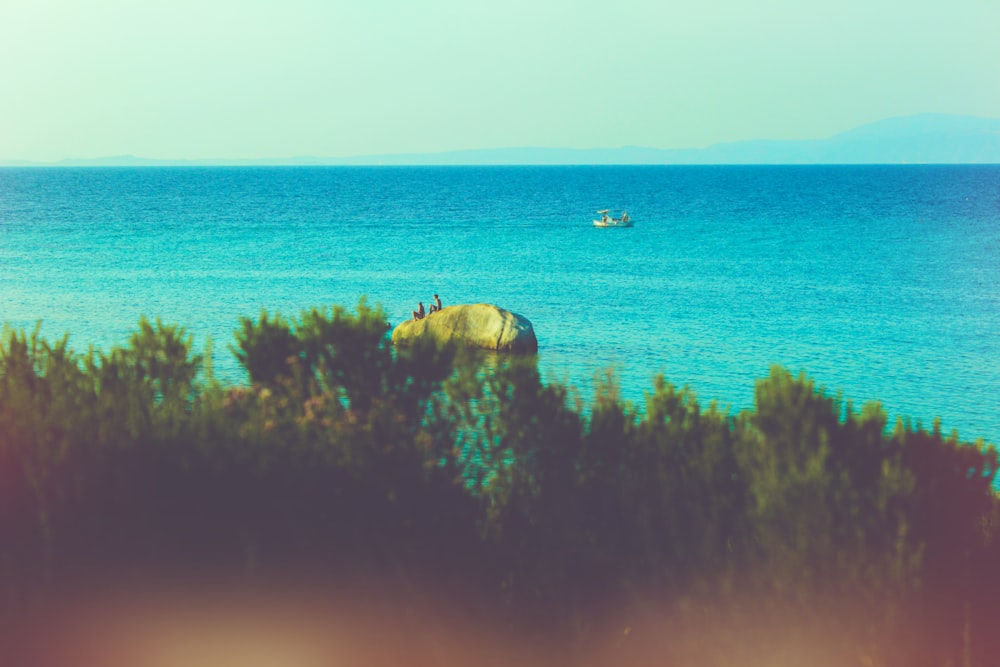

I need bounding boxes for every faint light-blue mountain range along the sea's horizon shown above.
[0,114,1000,167]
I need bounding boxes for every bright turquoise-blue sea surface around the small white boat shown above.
[0,166,1000,442]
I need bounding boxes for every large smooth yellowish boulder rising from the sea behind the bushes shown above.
[392,303,538,354]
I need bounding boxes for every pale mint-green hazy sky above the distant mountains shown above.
[0,0,1000,161]
